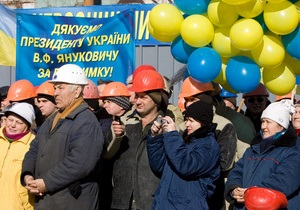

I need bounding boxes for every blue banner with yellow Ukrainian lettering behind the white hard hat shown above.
[16,10,135,86]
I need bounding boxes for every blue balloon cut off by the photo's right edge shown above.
[281,27,300,60]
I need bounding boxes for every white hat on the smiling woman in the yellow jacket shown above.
[5,102,35,126]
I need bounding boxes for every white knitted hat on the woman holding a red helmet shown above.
[261,100,294,129]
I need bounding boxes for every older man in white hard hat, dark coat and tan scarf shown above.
[21,64,104,210]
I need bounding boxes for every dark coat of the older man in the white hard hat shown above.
[21,103,104,210]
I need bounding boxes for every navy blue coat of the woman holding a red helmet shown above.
[225,126,300,210]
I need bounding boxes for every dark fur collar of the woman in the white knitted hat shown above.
[251,125,298,147]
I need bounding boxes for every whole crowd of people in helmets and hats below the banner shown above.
[0,64,300,210]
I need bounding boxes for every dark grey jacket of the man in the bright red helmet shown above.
[111,112,159,210]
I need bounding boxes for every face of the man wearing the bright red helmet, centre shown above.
[135,93,158,117]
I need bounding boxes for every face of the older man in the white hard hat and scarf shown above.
[54,83,80,111]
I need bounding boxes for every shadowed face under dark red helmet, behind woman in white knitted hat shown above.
[245,96,268,114]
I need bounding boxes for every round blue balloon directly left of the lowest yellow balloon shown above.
[225,56,261,93]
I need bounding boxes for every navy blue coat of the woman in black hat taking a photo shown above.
[147,125,220,210]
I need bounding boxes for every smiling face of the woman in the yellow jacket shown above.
[5,114,28,134]
